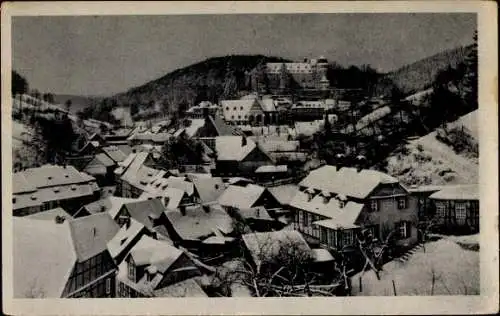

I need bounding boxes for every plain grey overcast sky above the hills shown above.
[12,13,476,95]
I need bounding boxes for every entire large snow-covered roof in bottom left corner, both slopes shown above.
[13,214,119,298]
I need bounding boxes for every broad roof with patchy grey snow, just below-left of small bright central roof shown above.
[165,205,233,240]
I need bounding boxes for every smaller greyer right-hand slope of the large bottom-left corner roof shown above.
[69,213,120,262]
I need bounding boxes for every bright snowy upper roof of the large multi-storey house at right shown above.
[299,165,399,199]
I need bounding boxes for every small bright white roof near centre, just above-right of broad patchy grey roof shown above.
[217,184,266,209]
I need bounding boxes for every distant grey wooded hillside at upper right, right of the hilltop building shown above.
[377,45,472,95]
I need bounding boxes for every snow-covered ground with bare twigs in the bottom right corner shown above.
[352,237,480,296]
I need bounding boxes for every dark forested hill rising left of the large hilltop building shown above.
[109,55,287,111]
